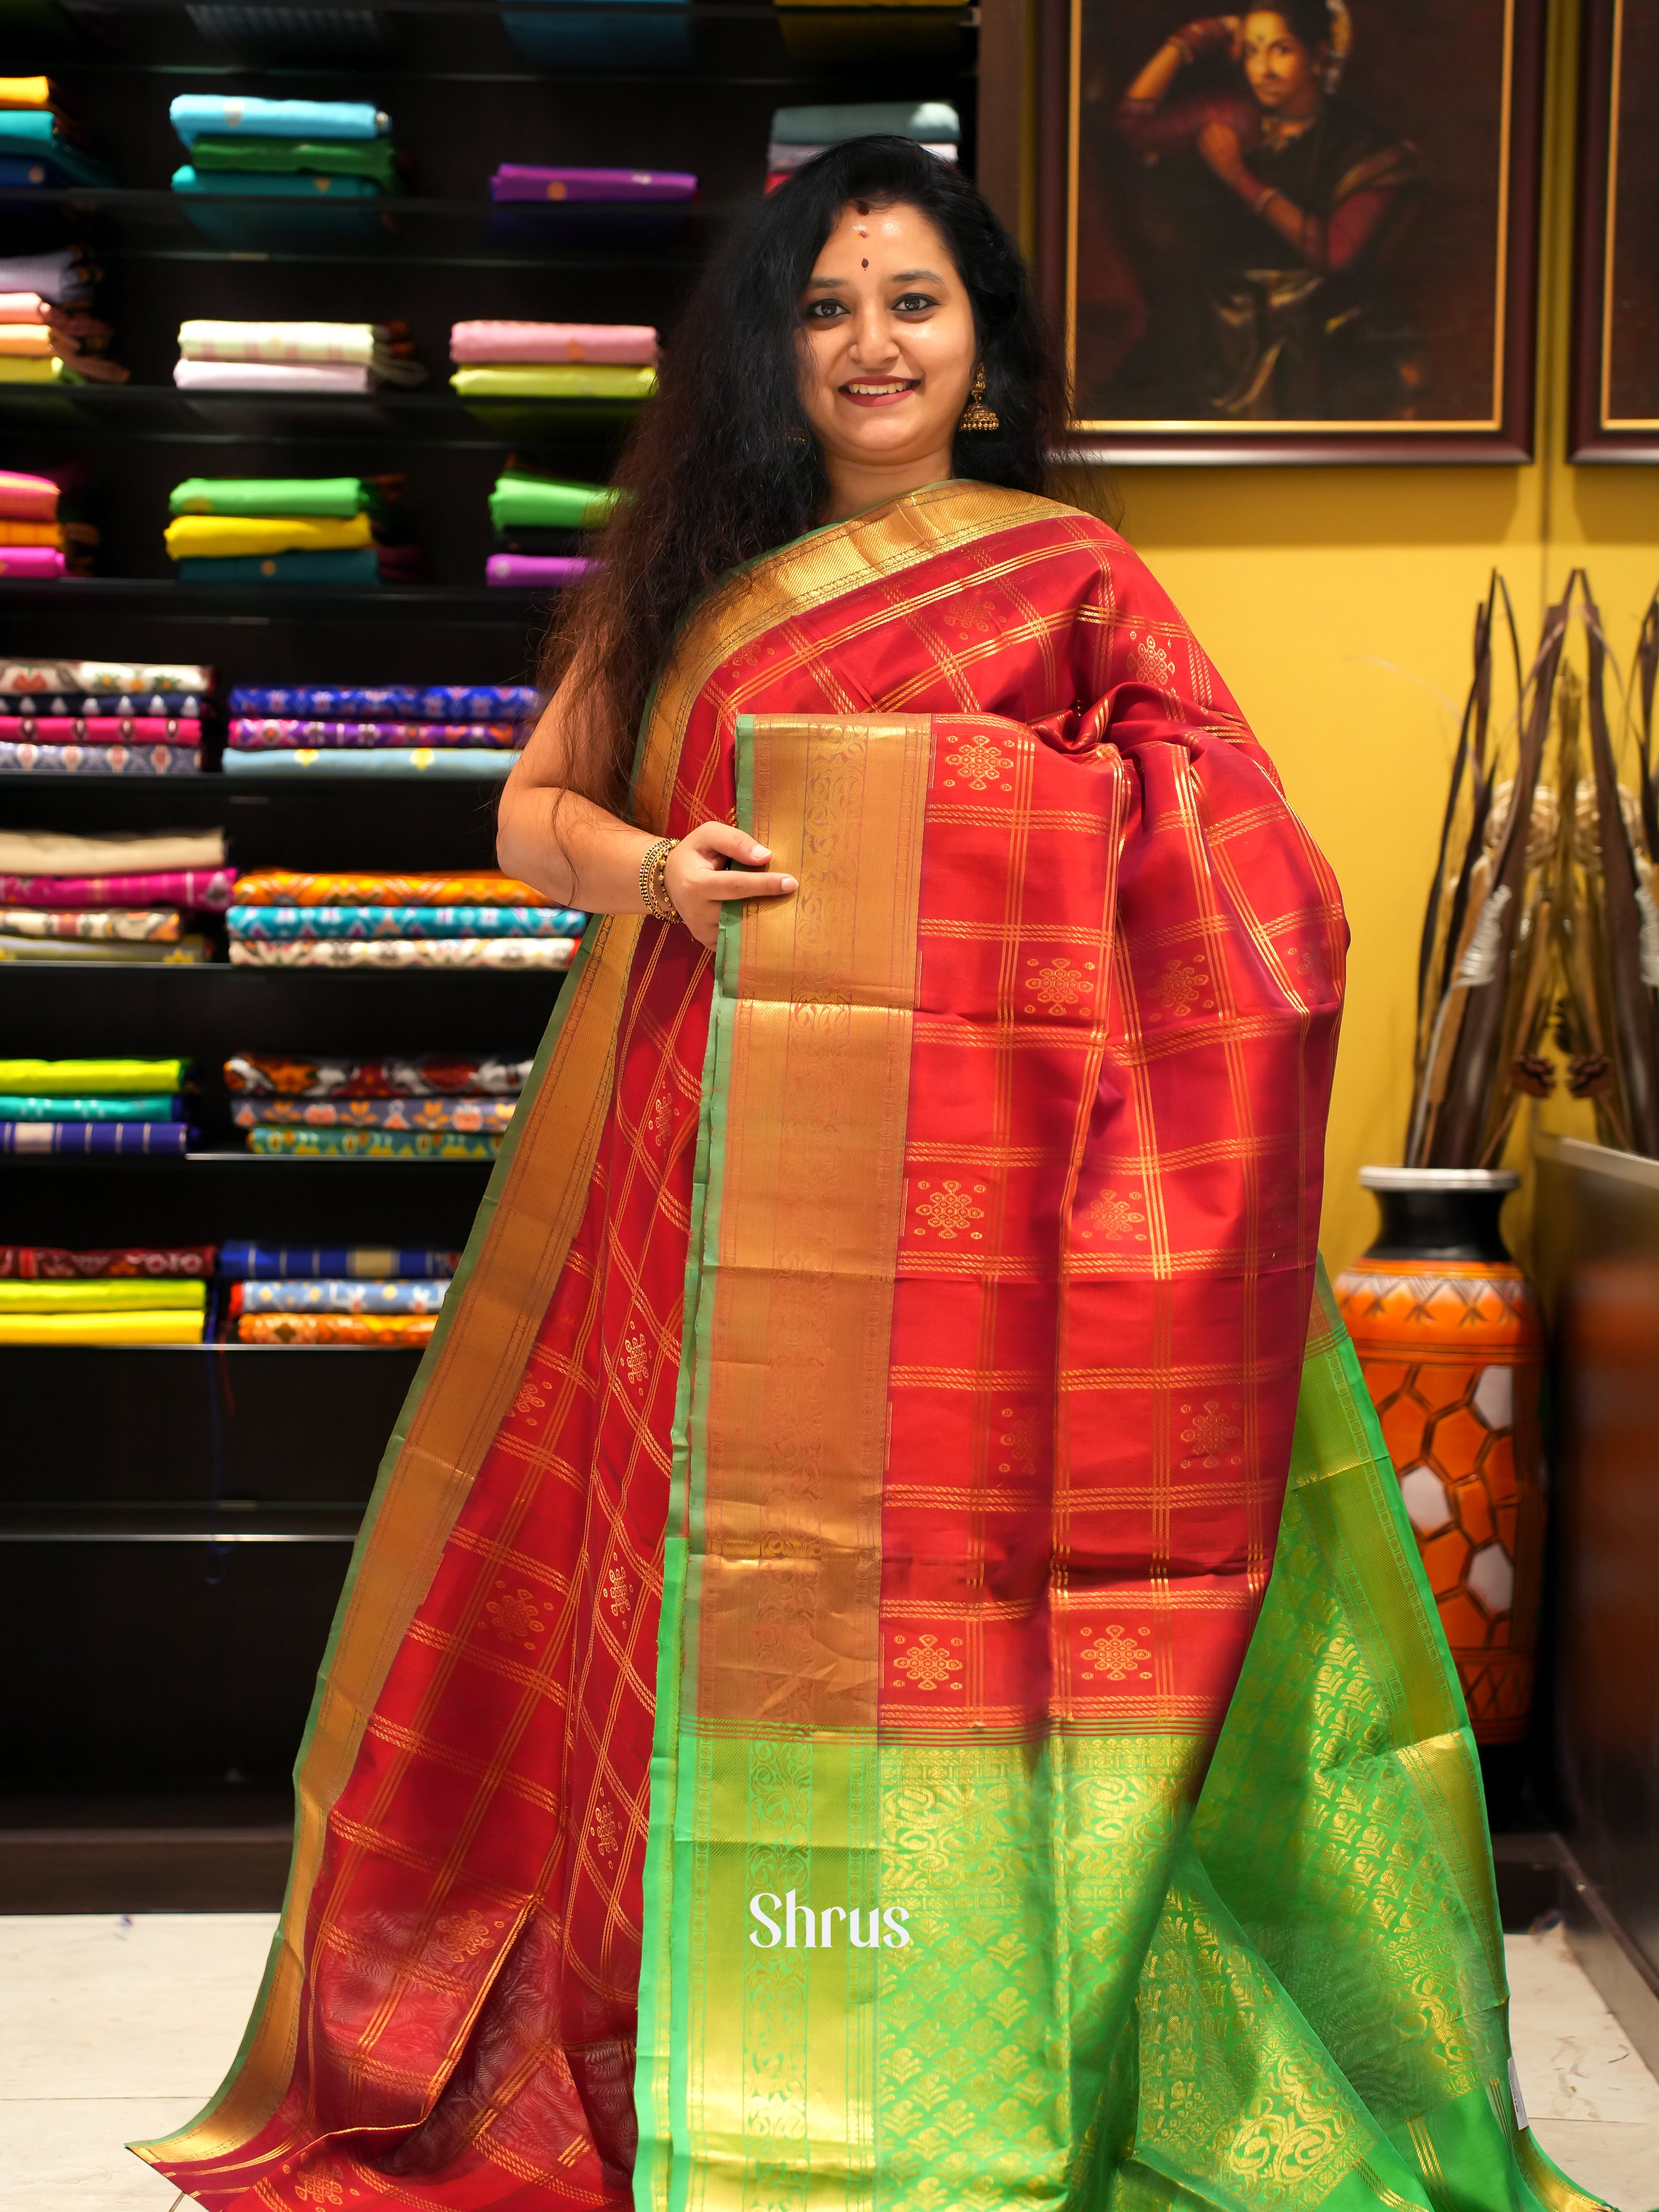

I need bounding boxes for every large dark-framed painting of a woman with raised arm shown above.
[1037,0,1557,462]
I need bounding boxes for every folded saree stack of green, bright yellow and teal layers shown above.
[166,476,425,586]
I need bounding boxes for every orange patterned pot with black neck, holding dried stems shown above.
[1336,1168,1544,1743]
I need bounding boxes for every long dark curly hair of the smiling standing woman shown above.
[540,137,1066,808]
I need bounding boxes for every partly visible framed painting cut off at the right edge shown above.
[1573,0,1659,460]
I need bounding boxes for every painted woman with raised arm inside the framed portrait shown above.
[1117,0,1427,422]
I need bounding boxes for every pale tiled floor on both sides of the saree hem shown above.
[0,1914,1659,2212]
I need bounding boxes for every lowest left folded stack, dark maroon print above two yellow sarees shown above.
[0,1245,212,1345]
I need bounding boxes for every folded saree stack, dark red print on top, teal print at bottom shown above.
[225,1053,531,1159]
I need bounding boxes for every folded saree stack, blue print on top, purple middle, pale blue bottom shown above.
[223,684,538,778]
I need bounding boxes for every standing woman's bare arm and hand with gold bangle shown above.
[495,664,797,945]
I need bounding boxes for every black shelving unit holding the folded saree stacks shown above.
[0,0,975,1858]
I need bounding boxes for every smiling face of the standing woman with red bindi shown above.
[801,199,978,467]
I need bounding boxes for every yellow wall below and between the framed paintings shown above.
[1070,0,1659,1267]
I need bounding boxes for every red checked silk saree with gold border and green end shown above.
[142,482,1619,2212]
